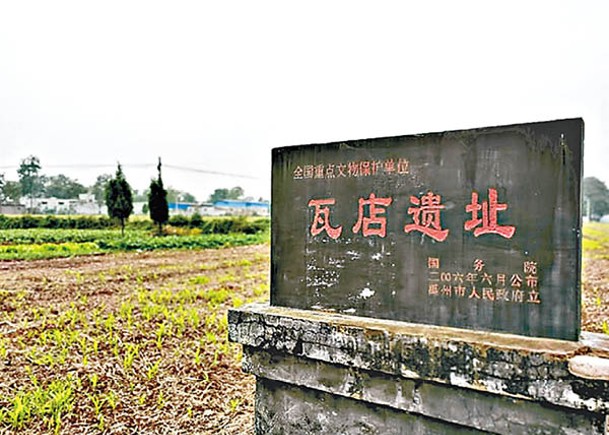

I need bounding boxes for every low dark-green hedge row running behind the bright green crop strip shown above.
[0,214,270,234]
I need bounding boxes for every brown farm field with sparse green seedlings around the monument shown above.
[0,224,609,434]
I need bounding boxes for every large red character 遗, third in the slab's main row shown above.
[404,191,450,242]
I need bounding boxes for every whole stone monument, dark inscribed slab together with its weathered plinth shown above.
[229,119,609,434]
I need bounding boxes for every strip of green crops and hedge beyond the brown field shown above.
[0,215,269,260]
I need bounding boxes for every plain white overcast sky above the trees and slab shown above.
[0,0,609,200]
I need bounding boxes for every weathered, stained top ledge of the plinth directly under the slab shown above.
[229,305,609,414]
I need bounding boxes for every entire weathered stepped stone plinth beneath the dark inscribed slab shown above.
[229,305,609,434]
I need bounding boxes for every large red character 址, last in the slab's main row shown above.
[464,188,516,239]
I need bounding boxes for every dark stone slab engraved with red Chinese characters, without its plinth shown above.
[271,119,583,340]
